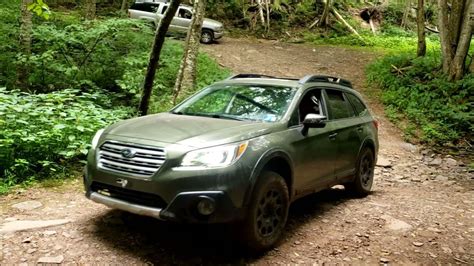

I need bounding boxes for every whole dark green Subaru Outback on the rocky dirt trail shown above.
[84,74,378,250]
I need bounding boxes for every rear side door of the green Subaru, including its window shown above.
[324,89,362,178]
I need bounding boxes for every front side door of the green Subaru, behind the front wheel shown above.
[292,88,337,195]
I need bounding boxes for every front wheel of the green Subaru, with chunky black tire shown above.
[240,171,290,252]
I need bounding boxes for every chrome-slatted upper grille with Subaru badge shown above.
[99,141,166,177]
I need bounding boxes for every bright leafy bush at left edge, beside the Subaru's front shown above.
[0,88,132,190]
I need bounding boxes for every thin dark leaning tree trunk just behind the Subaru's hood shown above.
[138,0,181,115]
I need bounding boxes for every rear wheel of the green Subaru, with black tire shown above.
[345,148,375,197]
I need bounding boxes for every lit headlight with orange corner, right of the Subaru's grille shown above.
[176,142,248,170]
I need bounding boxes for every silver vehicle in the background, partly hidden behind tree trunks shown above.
[128,1,224,44]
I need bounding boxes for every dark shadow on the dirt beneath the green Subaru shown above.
[92,189,366,264]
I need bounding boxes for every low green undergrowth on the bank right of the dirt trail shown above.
[367,53,474,145]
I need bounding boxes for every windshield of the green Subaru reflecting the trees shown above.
[172,85,296,122]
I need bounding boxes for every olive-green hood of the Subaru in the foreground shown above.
[105,113,277,148]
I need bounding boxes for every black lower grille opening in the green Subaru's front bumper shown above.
[91,181,167,208]
